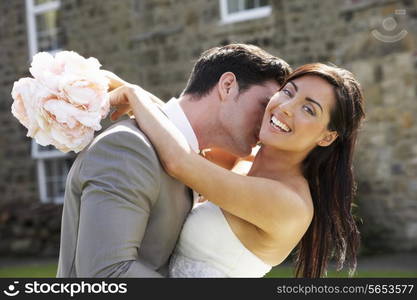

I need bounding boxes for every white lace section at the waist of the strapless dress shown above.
[169,254,227,278]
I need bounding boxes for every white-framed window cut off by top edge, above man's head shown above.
[220,0,271,23]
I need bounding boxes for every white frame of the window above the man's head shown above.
[220,0,272,24]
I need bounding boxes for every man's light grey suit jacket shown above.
[57,120,192,277]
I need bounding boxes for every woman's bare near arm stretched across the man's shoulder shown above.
[112,86,311,236]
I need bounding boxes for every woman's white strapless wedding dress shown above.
[169,201,271,277]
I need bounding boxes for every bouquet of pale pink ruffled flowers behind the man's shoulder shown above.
[12,51,110,152]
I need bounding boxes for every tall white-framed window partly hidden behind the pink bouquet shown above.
[26,0,73,203]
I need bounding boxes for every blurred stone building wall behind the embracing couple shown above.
[0,0,417,255]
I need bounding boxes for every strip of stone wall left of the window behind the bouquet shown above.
[0,0,38,204]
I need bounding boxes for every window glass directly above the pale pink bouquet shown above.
[36,10,62,51]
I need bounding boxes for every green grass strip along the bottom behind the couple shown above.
[0,263,417,278]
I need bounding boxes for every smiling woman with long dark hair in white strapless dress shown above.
[106,63,364,277]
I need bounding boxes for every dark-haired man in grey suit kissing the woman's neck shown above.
[57,44,290,277]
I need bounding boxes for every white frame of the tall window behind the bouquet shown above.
[26,0,70,203]
